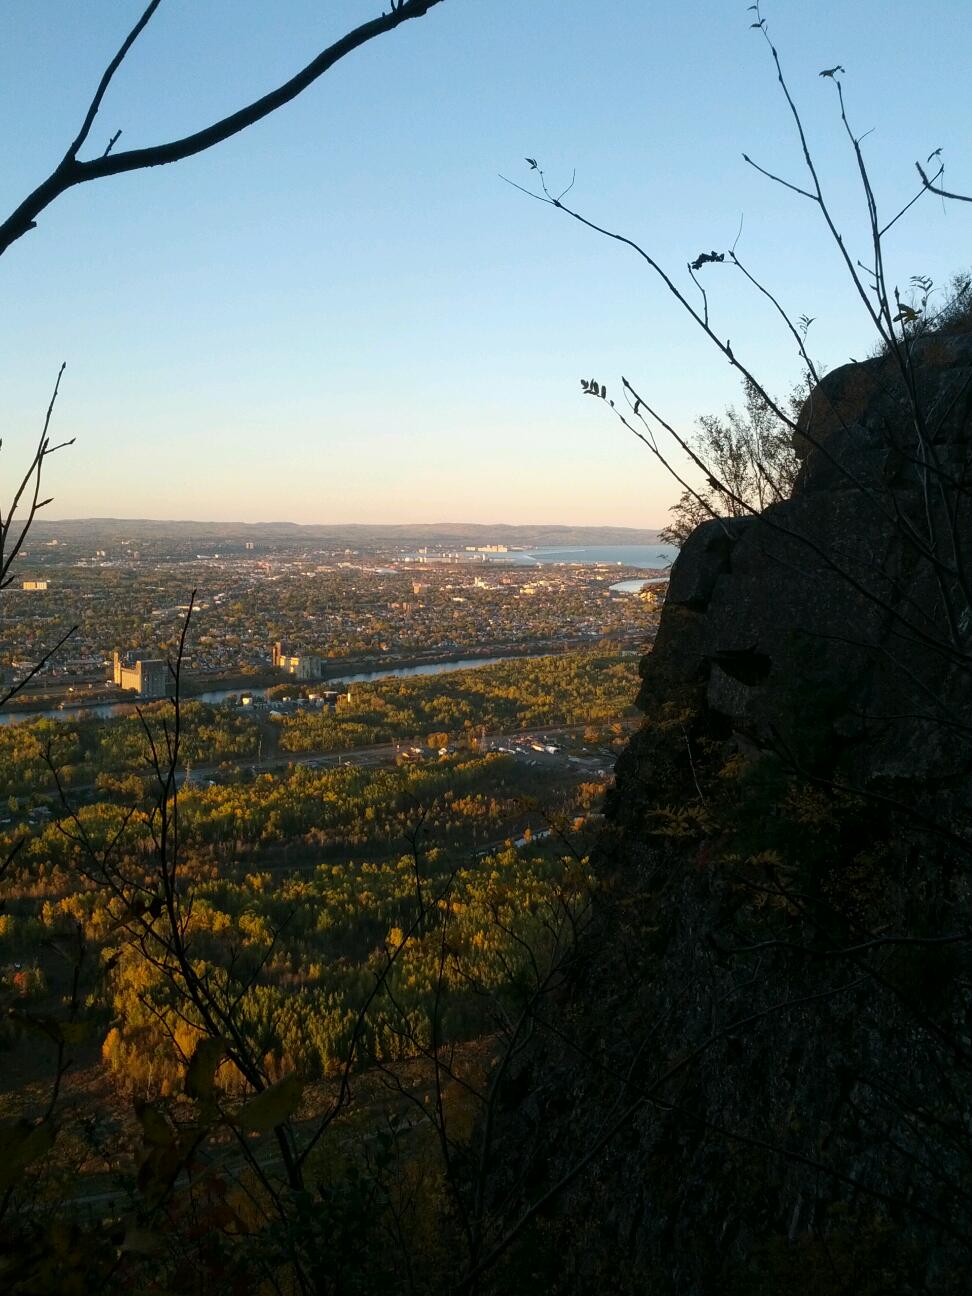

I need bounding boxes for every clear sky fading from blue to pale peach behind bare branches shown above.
[0,0,972,526]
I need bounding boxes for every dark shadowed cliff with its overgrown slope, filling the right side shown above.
[489,333,972,1296]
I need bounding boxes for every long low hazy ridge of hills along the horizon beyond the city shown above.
[32,517,658,548]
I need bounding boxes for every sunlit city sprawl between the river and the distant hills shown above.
[0,539,657,697]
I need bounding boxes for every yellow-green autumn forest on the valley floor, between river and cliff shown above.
[0,653,638,1282]
